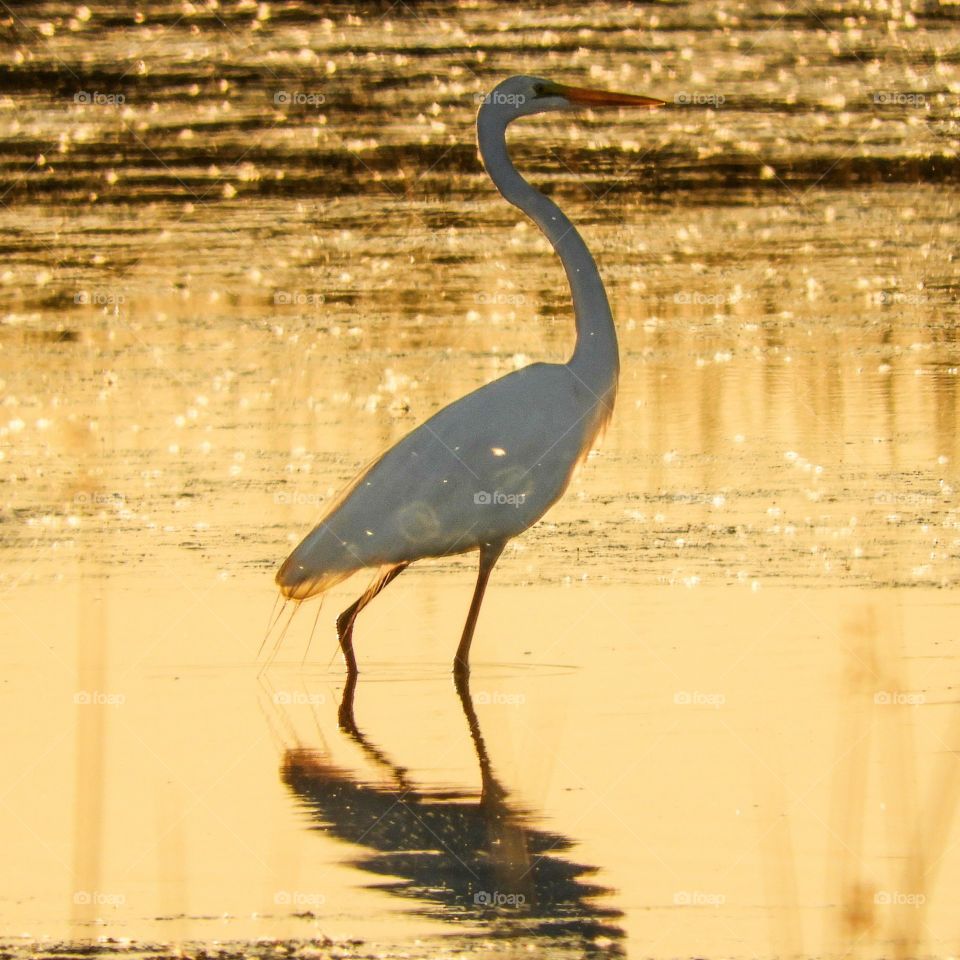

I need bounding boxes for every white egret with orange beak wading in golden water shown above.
[276,76,666,683]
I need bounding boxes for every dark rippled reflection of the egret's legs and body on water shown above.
[281,680,624,955]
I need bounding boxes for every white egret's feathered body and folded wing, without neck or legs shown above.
[277,363,612,596]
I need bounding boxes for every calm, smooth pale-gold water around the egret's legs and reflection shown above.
[0,563,960,956]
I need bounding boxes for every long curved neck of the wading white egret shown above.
[477,110,620,405]
